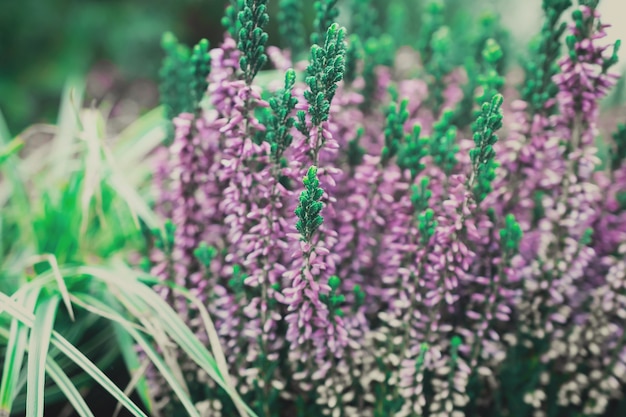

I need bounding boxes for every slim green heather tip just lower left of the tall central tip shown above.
[266,69,298,164]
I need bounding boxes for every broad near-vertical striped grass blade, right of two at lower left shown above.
[26,296,61,417]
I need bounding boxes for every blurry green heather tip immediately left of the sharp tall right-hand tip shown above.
[429,110,459,175]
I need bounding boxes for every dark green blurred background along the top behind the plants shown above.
[0,0,626,134]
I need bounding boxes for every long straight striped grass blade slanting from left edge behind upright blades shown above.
[0,293,147,417]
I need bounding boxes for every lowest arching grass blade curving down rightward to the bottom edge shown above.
[72,294,200,417]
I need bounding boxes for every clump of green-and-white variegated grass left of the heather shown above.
[0,88,254,417]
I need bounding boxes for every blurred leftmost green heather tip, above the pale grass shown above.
[159,32,193,120]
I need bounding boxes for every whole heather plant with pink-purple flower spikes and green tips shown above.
[150,0,626,417]
